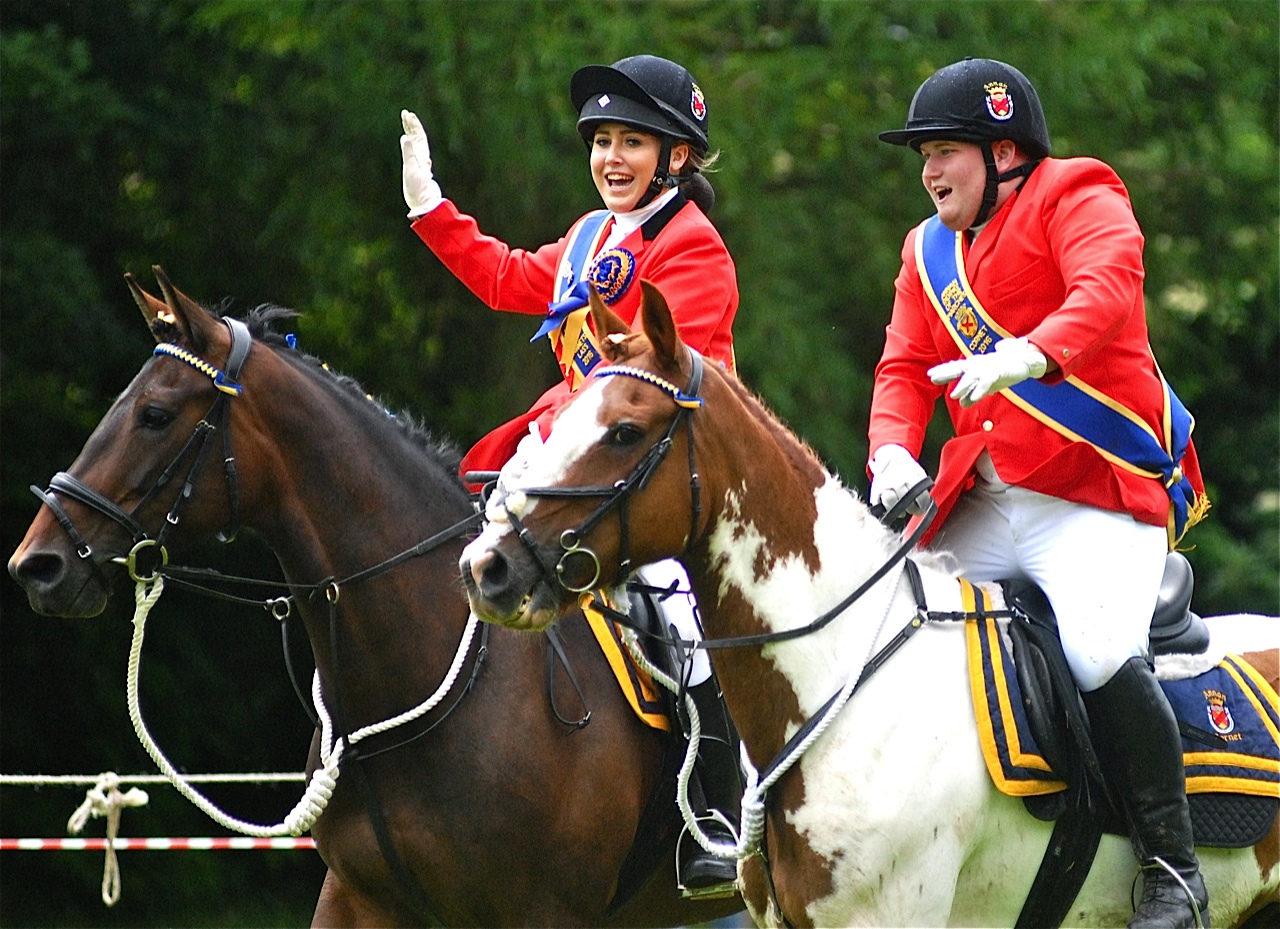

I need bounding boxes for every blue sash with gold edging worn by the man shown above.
[915,216,1208,544]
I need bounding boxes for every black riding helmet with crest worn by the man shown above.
[879,58,1050,225]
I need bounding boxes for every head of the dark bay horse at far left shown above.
[9,266,251,617]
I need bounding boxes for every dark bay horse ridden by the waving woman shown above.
[9,267,740,926]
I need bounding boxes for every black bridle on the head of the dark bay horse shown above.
[31,316,253,586]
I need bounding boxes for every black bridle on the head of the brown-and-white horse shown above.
[503,348,703,594]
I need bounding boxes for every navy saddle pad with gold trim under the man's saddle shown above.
[961,593,1280,797]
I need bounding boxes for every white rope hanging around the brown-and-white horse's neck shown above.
[622,564,905,859]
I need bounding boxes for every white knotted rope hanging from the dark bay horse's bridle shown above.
[127,576,479,837]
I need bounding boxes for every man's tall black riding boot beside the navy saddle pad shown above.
[1084,658,1208,929]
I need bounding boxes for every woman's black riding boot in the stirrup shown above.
[680,677,742,891]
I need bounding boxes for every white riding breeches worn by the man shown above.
[931,480,1169,691]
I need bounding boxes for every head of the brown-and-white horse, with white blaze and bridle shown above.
[461,282,722,628]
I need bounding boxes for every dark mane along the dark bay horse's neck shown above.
[151,298,462,482]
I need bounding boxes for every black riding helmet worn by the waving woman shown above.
[568,55,708,206]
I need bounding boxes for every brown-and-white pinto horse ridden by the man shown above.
[461,284,1280,926]
